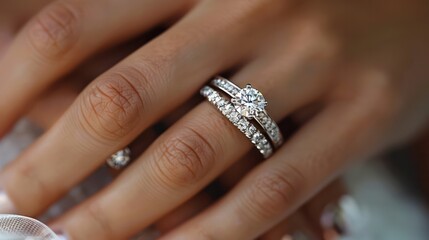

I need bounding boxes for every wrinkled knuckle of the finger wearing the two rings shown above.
[155,128,215,187]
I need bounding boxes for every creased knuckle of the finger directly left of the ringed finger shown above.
[81,68,144,140]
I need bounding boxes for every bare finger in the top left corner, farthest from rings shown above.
[0,0,190,136]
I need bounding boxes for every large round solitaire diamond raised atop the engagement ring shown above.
[232,84,267,118]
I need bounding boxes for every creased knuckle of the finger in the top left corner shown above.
[28,1,80,60]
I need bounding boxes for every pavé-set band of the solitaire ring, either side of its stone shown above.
[211,76,283,148]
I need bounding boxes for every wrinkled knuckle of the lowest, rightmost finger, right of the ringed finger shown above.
[243,166,304,220]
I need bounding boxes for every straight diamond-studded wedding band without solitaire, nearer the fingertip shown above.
[201,86,273,158]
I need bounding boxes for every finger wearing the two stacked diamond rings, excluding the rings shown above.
[50,19,336,239]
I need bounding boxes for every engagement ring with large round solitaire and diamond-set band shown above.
[212,76,283,148]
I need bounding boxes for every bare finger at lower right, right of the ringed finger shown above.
[164,71,388,239]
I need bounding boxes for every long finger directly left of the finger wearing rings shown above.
[2,1,290,218]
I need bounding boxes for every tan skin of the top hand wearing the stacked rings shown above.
[0,0,429,239]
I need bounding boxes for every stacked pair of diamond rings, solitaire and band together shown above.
[201,77,283,158]
